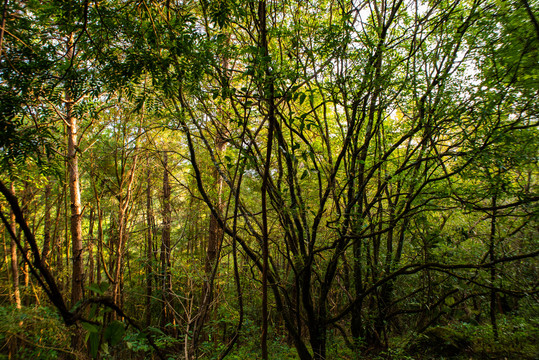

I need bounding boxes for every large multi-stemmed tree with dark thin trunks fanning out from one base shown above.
[142,2,536,359]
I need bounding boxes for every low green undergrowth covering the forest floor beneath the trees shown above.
[0,306,539,360]
